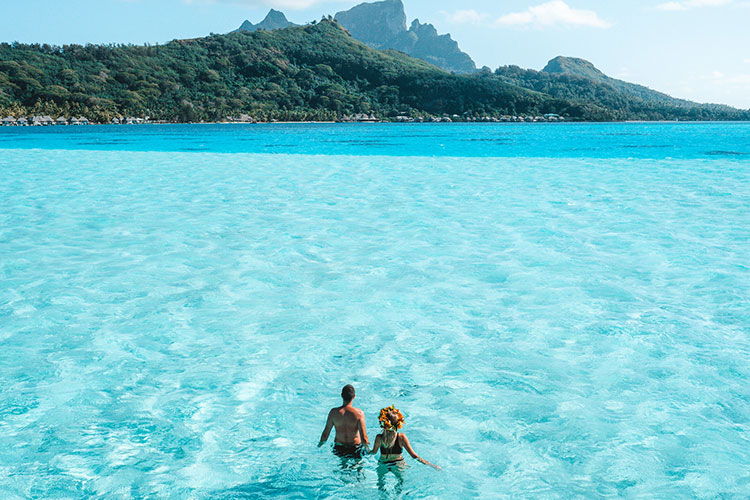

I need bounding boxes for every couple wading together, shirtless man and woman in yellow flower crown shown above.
[318,385,440,470]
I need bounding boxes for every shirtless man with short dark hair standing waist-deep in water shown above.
[318,385,370,457]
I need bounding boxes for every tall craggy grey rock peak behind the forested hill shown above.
[334,0,476,73]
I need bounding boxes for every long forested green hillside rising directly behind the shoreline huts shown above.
[0,21,750,121]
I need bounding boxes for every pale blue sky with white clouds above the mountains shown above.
[0,0,750,109]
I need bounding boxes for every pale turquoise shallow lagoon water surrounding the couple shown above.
[0,124,750,499]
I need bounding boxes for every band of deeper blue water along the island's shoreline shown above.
[0,122,750,160]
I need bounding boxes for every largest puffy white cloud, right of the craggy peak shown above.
[495,0,612,28]
